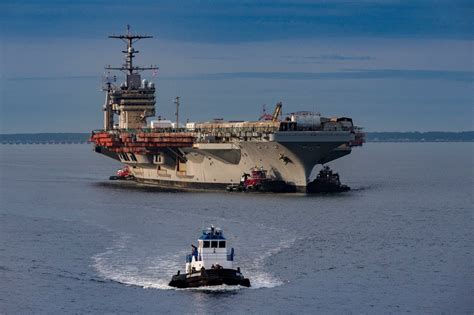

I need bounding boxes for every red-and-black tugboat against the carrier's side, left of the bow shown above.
[226,167,288,192]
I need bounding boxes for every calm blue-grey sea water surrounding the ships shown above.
[0,143,474,314]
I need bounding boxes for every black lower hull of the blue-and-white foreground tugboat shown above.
[169,269,250,288]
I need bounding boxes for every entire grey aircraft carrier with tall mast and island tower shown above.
[90,30,363,192]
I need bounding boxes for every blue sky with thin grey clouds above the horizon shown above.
[0,0,474,133]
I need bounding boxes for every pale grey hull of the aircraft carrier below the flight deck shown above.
[96,132,353,192]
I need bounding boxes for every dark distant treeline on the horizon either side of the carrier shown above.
[0,131,474,144]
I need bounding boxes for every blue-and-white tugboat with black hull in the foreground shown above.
[169,225,250,288]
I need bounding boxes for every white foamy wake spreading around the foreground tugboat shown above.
[92,227,296,291]
